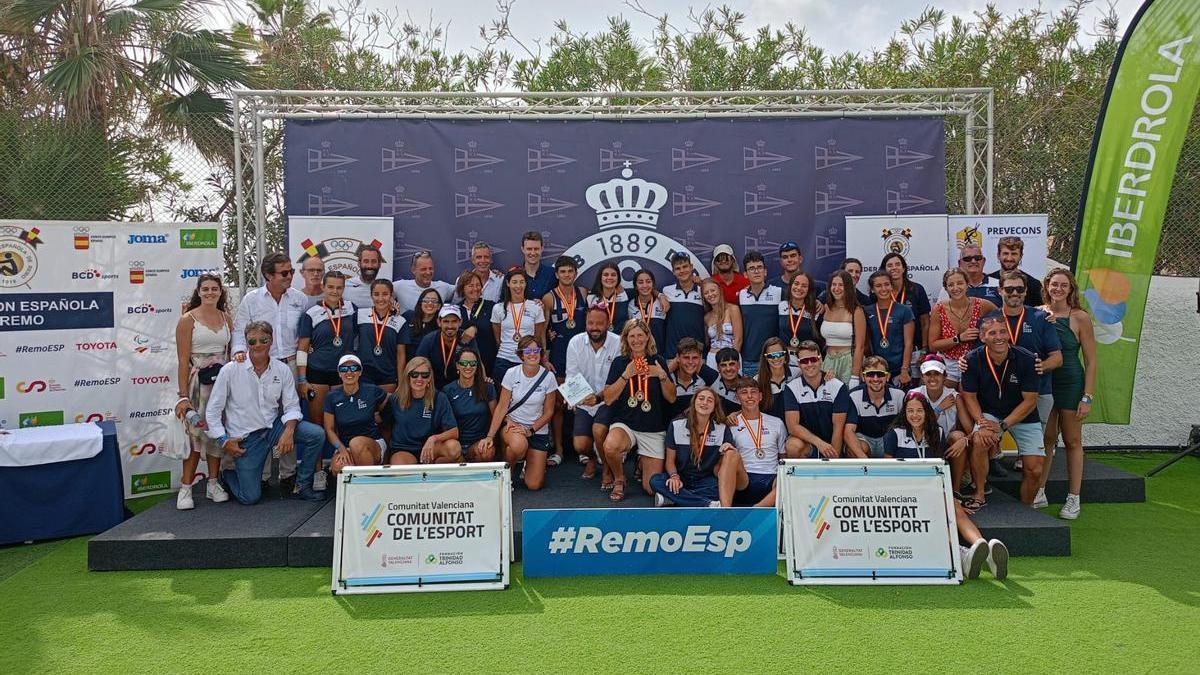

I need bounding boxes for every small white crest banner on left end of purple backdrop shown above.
[288,216,396,283]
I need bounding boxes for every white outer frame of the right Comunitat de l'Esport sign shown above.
[776,459,962,586]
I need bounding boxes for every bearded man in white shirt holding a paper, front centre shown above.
[566,306,620,478]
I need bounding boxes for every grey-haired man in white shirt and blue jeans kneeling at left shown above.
[204,321,325,504]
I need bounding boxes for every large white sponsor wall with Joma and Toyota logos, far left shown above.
[0,221,222,496]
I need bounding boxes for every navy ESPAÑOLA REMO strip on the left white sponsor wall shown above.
[0,293,113,331]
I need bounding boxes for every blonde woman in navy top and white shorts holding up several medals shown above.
[604,321,676,502]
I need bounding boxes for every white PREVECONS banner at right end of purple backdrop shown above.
[938,214,1050,279]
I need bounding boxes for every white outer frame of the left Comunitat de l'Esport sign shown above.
[330,462,514,596]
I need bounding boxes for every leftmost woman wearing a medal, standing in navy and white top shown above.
[296,271,355,420]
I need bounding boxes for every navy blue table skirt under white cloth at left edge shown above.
[0,422,125,544]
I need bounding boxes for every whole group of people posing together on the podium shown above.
[176,227,1096,571]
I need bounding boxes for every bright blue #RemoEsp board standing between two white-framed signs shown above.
[521,508,778,577]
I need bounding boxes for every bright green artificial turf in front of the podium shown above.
[0,458,1200,674]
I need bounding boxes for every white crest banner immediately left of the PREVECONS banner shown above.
[846,215,956,297]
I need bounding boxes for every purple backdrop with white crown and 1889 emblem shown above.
[284,118,946,285]
